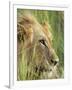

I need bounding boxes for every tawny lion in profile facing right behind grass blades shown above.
[17,14,59,80]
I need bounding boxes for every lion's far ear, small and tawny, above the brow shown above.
[42,21,53,41]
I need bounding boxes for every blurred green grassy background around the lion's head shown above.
[17,9,64,80]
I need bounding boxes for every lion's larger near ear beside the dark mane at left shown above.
[17,21,33,47]
